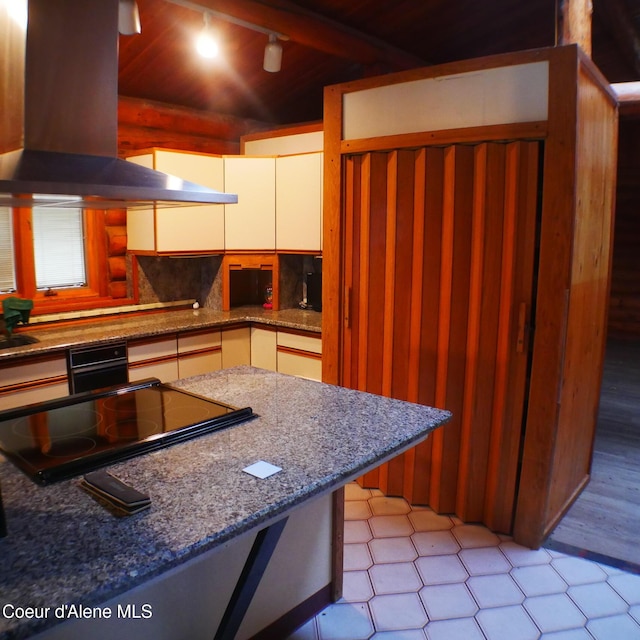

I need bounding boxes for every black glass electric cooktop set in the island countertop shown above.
[0,378,254,484]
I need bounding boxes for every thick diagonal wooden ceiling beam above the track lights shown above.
[167,0,427,71]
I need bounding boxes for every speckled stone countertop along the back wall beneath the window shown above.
[0,307,322,366]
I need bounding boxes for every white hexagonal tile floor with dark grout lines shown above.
[289,483,640,640]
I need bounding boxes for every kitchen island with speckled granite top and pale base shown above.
[0,367,450,639]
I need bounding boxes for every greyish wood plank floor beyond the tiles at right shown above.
[544,339,640,572]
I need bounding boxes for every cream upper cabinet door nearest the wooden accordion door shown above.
[276,153,323,251]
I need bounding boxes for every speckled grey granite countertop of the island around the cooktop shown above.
[0,367,450,638]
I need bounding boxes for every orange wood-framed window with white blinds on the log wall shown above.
[0,207,107,312]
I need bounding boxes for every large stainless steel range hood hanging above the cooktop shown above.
[0,0,238,209]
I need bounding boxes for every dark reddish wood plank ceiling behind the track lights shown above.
[119,0,640,124]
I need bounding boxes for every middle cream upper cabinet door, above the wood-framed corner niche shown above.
[224,156,276,251]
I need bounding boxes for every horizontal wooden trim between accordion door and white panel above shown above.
[340,121,548,154]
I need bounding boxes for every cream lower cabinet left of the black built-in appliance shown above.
[0,354,69,410]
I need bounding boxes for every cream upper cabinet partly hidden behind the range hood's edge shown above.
[127,149,224,254]
